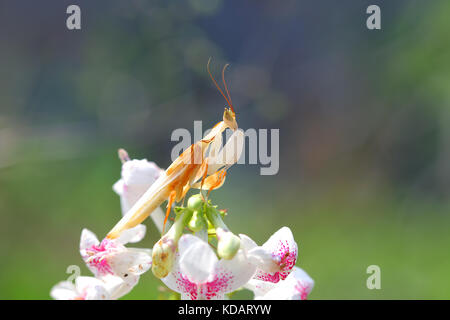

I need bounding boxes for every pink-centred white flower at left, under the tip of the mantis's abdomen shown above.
[80,225,152,296]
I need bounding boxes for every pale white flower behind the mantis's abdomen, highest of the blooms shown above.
[113,154,164,234]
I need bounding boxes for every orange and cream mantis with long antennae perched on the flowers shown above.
[107,61,244,239]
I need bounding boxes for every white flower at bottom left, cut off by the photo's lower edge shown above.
[50,277,123,300]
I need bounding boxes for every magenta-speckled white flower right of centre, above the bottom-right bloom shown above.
[240,227,298,283]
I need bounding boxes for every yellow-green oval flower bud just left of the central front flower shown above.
[152,235,177,279]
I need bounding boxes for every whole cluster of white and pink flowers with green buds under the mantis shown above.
[50,150,314,300]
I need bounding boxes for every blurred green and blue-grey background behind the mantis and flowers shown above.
[0,0,450,299]
